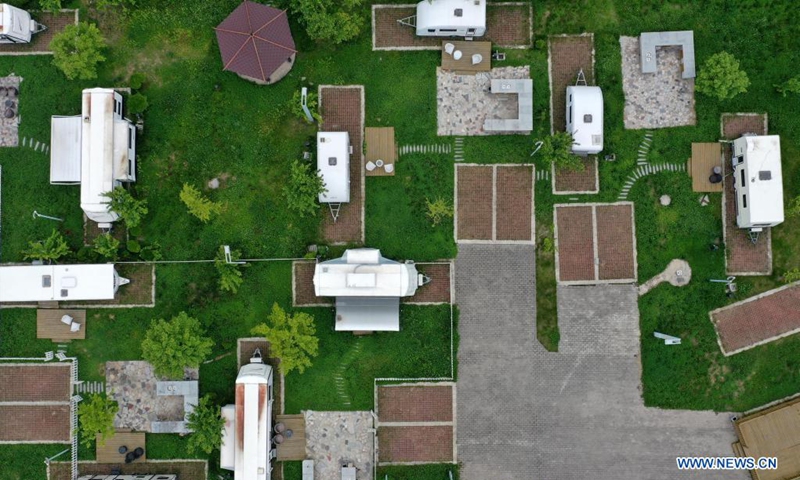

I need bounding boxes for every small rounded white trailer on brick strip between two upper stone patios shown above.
[566,86,603,156]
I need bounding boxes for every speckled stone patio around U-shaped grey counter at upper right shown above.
[619,37,697,129]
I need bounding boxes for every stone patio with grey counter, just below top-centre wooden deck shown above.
[436,66,531,136]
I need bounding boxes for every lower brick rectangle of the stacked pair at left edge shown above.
[0,405,70,442]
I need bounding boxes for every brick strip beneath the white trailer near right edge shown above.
[722,114,772,275]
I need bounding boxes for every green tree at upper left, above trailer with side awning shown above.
[50,22,106,80]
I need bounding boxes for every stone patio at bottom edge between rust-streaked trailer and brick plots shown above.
[304,411,374,480]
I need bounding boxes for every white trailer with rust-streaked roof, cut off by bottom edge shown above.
[219,352,274,480]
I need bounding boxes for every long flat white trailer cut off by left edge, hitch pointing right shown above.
[0,264,129,302]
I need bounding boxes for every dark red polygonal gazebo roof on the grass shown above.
[214,0,297,84]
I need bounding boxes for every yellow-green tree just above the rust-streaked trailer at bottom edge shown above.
[251,303,319,375]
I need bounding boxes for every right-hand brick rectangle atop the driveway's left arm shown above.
[496,166,533,240]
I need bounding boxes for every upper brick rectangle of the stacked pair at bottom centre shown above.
[378,385,453,422]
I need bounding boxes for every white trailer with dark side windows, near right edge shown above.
[731,135,783,232]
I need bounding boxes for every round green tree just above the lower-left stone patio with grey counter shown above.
[142,312,214,378]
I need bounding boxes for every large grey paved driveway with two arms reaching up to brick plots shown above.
[456,244,748,480]
